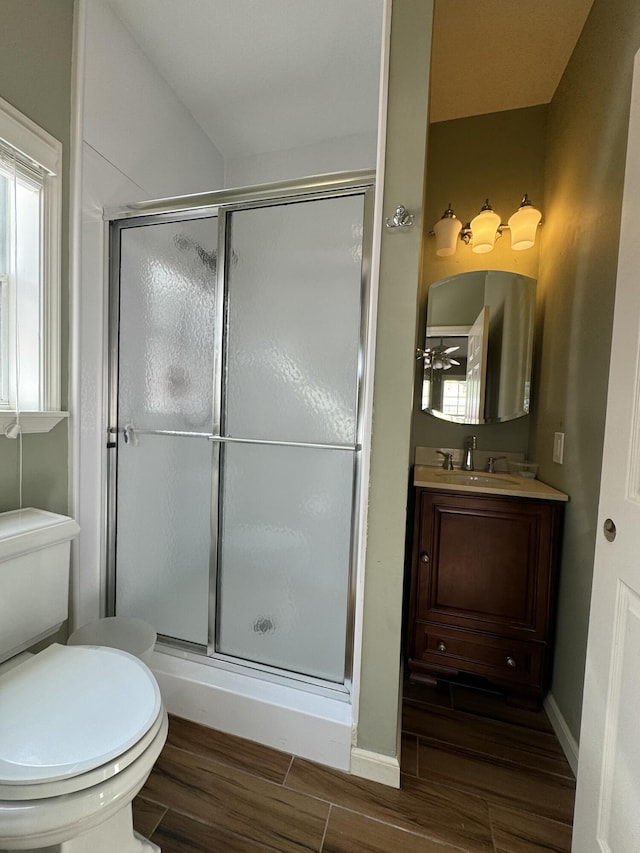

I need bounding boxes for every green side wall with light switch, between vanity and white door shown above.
[532,0,640,740]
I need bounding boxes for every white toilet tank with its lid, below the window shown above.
[0,508,80,663]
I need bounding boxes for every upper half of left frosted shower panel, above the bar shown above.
[118,217,218,432]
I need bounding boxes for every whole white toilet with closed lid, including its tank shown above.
[0,509,168,853]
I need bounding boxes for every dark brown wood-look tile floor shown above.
[134,683,575,853]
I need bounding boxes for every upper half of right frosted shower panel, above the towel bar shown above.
[225,194,364,444]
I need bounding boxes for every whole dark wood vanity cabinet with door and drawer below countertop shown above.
[408,488,563,702]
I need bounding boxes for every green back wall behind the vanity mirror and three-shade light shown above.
[412,105,547,460]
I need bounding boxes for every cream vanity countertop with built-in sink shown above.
[413,465,569,501]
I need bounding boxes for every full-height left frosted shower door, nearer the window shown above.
[110,216,220,646]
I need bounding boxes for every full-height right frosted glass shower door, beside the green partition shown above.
[217,195,363,681]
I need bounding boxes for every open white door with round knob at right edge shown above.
[572,52,640,853]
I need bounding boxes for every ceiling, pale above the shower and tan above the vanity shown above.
[108,0,593,157]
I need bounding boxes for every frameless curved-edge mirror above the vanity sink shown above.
[419,270,536,424]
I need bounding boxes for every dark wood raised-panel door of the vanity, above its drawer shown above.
[416,492,552,639]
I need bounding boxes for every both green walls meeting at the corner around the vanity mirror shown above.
[413,0,640,740]
